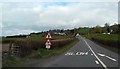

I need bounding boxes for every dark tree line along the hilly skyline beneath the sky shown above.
[3,23,120,38]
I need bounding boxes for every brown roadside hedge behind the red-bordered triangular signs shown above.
[10,38,76,57]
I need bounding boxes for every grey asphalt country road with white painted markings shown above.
[23,36,118,69]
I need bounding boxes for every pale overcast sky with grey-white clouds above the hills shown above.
[0,2,118,36]
